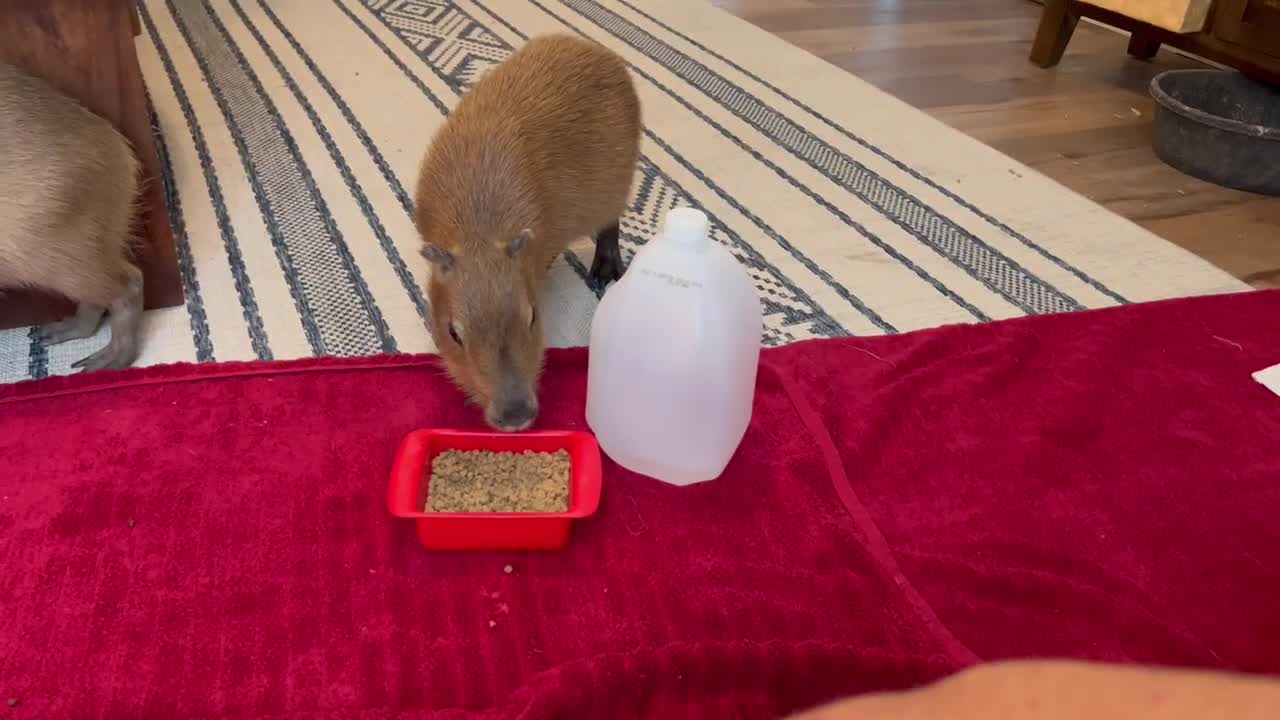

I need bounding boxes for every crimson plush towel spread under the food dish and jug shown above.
[0,288,1280,719]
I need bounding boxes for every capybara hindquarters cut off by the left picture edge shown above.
[0,63,142,370]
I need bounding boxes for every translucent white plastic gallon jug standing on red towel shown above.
[586,208,762,486]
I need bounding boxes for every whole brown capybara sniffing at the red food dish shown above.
[416,35,641,430]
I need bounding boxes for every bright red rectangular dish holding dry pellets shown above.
[387,430,600,550]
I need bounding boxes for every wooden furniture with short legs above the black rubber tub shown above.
[1030,0,1280,83]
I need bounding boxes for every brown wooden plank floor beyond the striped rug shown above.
[713,0,1280,287]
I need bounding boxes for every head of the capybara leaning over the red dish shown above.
[422,228,544,432]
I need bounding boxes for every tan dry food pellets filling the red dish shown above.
[426,450,571,512]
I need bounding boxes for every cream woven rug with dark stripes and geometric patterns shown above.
[0,0,1244,382]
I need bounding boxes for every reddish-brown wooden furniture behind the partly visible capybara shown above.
[0,0,183,328]
